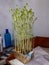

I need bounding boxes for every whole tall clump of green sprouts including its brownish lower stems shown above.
[11,3,36,63]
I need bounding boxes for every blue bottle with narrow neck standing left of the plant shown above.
[4,29,11,48]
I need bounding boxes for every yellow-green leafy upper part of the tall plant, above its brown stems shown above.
[11,3,34,39]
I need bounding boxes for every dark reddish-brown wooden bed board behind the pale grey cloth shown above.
[34,36,49,48]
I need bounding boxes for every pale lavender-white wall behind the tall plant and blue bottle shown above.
[0,0,49,46]
